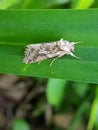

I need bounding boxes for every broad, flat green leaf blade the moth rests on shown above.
[0,9,98,83]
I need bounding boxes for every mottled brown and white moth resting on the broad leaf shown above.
[23,38,80,66]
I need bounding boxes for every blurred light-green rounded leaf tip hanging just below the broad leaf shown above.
[46,79,66,106]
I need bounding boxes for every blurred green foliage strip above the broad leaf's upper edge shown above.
[0,0,98,9]
